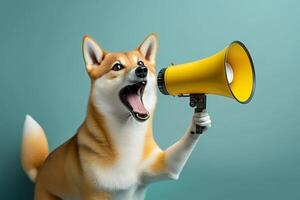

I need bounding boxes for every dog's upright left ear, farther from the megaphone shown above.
[82,36,104,72]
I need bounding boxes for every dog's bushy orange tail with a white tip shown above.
[21,115,48,182]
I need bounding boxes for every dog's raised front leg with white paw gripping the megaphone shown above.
[143,110,211,181]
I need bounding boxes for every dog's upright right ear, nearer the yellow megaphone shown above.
[138,33,158,64]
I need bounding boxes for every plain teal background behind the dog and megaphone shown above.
[0,0,300,200]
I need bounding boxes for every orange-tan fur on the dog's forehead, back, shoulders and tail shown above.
[22,35,165,200]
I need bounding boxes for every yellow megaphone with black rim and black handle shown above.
[157,41,255,134]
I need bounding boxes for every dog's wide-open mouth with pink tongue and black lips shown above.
[119,81,149,121]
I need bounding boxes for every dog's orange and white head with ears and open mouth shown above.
[82,34,157,122]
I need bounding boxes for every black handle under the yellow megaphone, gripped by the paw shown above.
[190,94,206,134]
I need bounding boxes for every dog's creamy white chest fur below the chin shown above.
[87,119,147,192]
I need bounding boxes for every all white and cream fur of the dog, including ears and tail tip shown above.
[24,35,211,200]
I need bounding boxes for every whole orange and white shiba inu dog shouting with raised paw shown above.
[21,34,211,200]
